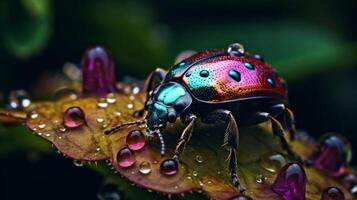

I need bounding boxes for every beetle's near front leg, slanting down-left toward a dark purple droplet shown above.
[173,114,197,160]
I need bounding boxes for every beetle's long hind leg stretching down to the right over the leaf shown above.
[257,112,311,165]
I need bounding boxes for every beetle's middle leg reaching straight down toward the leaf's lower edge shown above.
[203,110,244,192]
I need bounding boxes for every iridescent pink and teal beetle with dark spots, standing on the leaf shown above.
[105,43,299,190]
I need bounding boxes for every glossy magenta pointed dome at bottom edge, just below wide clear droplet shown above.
[272,162,307,200]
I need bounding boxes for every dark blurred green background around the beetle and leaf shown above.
[0,0,357,199]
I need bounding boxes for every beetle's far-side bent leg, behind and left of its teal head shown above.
[134,68,167,117]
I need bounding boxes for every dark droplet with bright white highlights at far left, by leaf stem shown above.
[9,90,31,109]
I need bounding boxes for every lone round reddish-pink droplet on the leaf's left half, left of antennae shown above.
[63,106,85,128]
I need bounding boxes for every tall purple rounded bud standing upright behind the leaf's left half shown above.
[81,46,117,96]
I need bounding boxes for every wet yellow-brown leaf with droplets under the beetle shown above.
[1,82,355,200]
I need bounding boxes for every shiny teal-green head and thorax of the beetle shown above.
[145,82,192,133]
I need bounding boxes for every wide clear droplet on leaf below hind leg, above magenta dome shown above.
[259,154,286,173]
